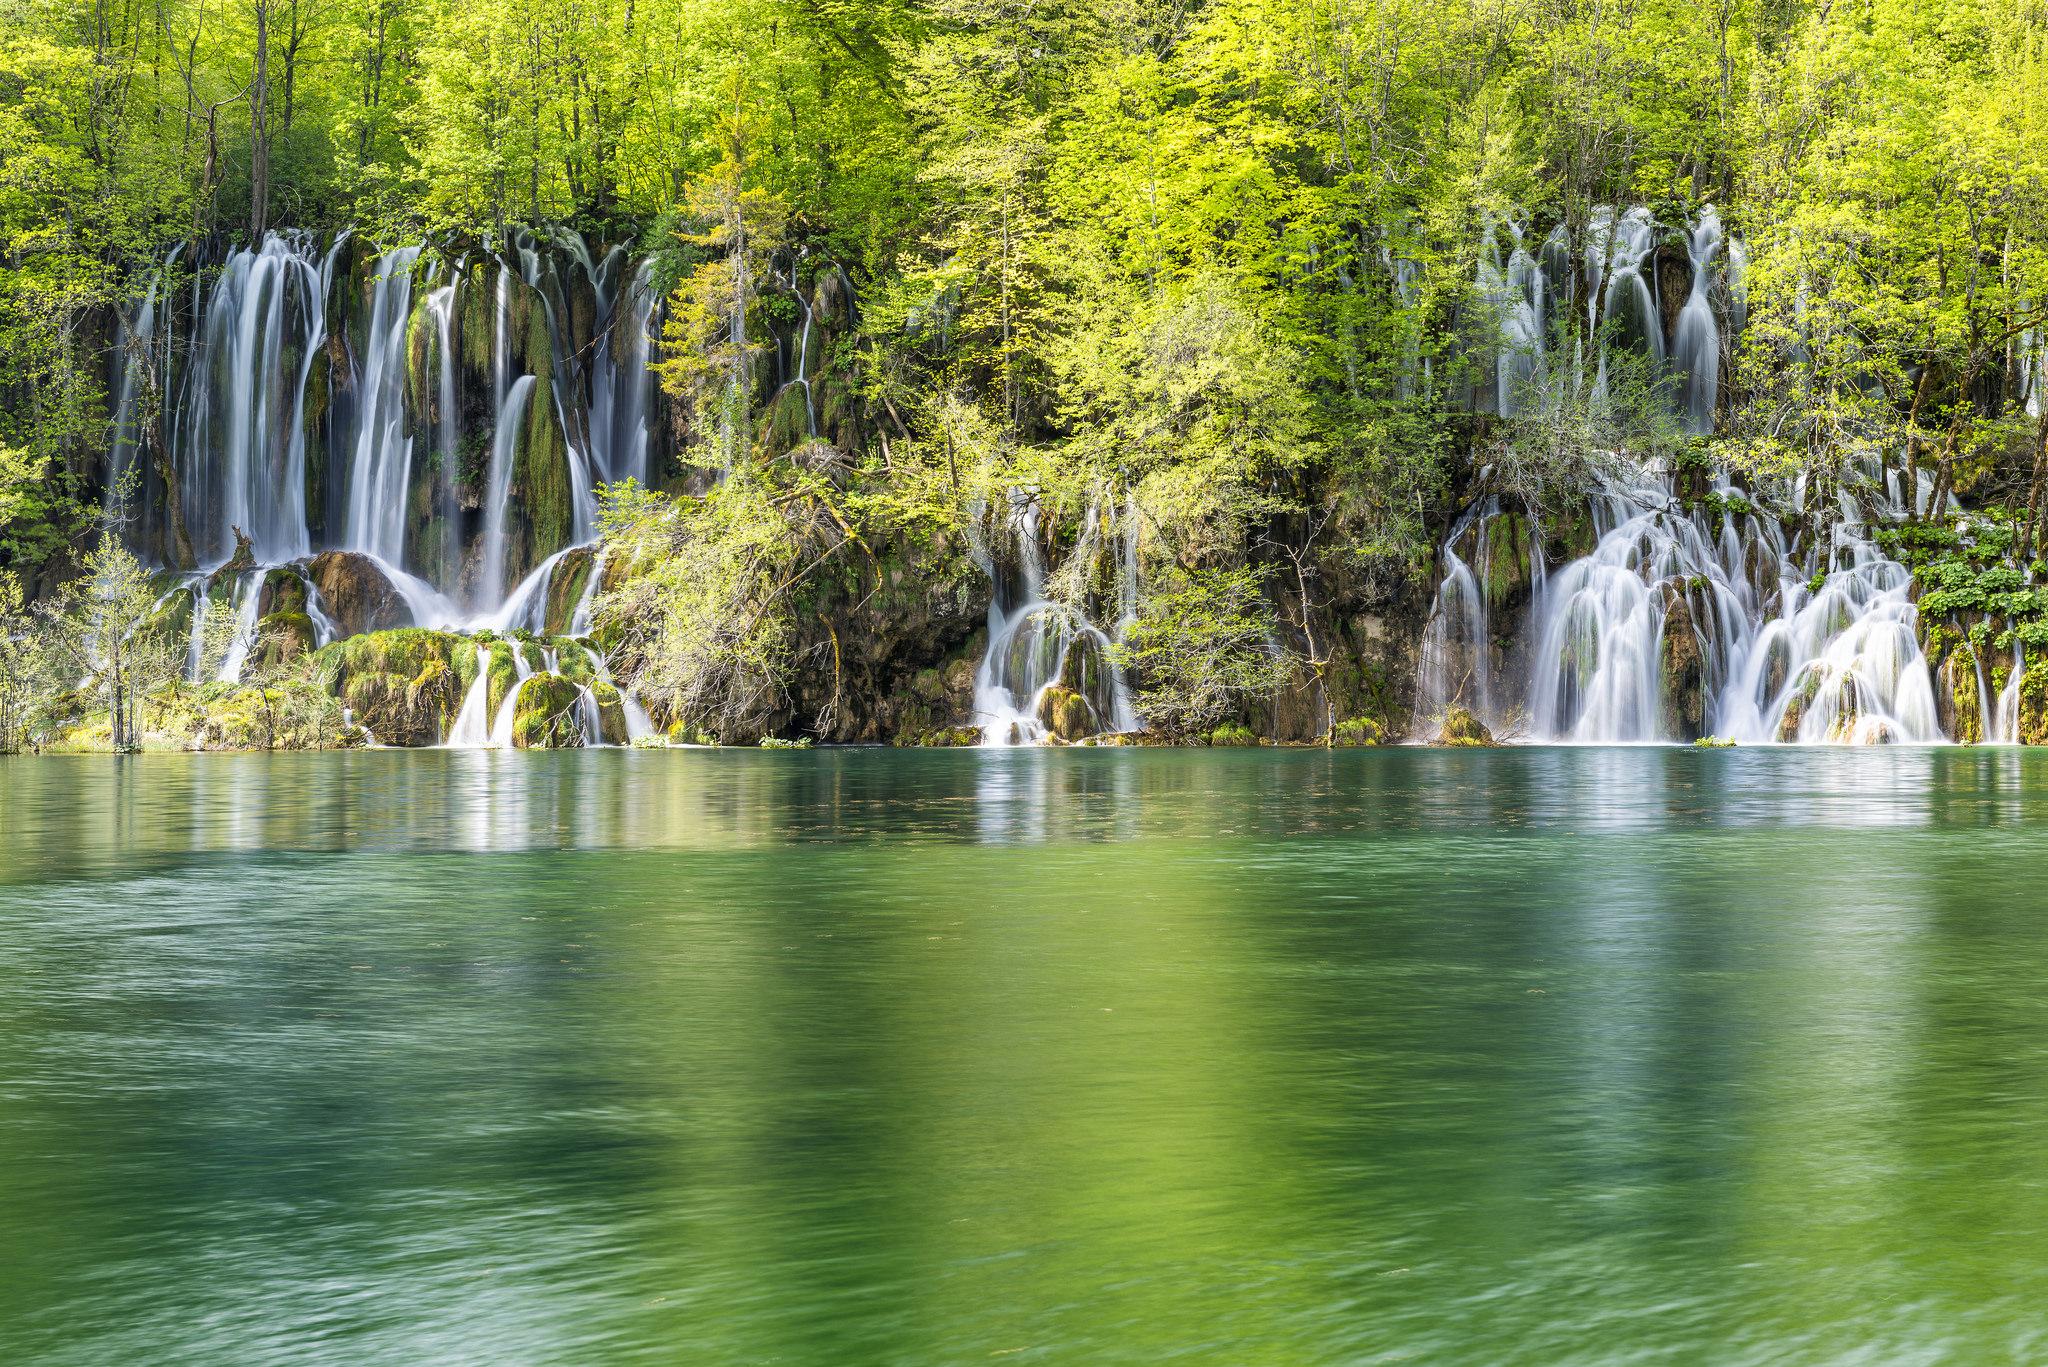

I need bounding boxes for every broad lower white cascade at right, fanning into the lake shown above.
[1482,475,1944,744]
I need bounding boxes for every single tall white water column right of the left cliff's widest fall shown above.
[342,246,420,566]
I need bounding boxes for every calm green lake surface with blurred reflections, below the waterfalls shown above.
[0,748,2048,1367]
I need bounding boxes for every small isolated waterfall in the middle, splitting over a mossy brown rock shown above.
[975,490,1139,746]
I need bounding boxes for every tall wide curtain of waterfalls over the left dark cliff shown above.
[104,232,662,742]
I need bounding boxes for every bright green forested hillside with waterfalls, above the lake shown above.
[0,0,2048,748]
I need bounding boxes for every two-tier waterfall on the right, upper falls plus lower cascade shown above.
[1417,207,1941,744]
